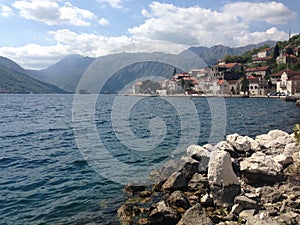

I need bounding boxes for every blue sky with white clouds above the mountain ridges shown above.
[0,0,300,69]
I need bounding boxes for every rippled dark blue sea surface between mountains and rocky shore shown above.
[0,95,300,225]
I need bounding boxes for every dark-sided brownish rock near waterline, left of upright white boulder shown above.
[162,172,187,192]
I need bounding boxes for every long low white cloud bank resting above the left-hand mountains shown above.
[0,29,132,69]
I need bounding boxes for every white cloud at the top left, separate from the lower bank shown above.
[13,0,96,26]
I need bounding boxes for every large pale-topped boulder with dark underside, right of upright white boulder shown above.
[240,152,283,184]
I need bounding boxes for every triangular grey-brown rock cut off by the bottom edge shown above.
[177,203,213,225]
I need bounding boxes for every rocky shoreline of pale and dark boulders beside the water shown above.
[117,130,300,225]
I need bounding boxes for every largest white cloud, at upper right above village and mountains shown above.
[128,2,295,46]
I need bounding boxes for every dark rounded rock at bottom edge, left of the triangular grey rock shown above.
[149,201,180,225]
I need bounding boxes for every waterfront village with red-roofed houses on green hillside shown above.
[131,35,300,97]
